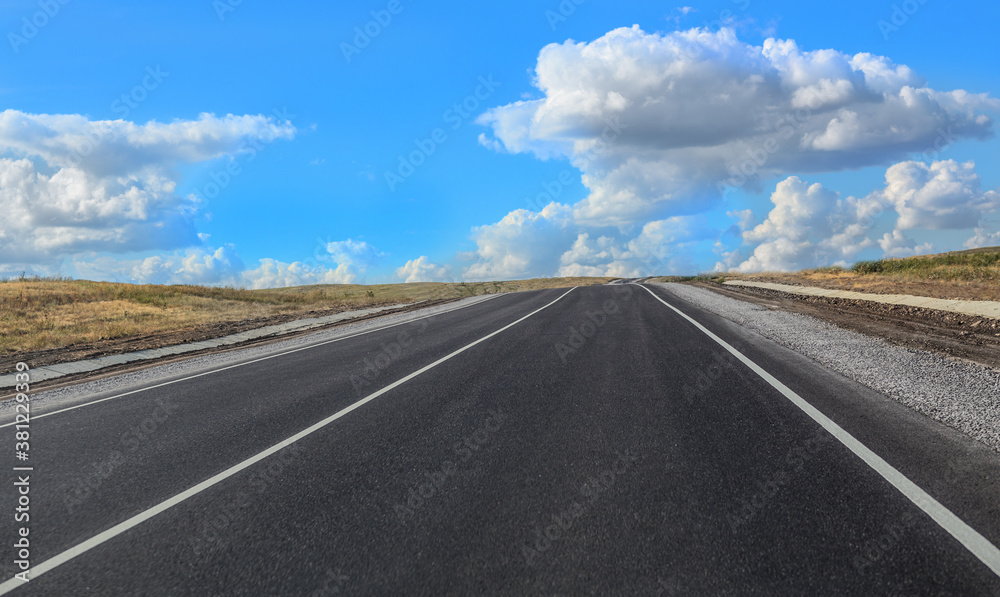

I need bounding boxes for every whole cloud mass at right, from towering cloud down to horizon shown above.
[465,26,1000,278]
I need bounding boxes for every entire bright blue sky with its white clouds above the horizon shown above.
[0,0,1000,287]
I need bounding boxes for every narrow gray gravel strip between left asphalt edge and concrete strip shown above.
[0,294,500,415]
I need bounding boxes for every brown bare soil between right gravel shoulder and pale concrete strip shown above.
[693,282,1000,368]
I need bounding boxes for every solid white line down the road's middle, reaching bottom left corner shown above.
[0,287,576,595]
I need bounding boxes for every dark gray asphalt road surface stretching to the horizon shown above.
[0,285,1000,596]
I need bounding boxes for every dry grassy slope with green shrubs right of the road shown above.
[726,247,1000,301]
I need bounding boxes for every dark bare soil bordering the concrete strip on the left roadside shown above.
[0,299,458,378]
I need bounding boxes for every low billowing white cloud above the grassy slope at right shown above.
[716,160,1000,272]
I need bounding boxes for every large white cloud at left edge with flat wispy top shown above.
[0,110,295,266]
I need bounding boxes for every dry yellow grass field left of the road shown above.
[0,278,610,356]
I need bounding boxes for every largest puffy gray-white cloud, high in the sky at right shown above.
[479,26,1000,226]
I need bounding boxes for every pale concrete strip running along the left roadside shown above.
[0,305,409,389]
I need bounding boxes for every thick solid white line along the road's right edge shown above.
[642,286,1000,576]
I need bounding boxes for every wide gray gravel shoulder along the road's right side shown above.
[657,284,1000,452]
